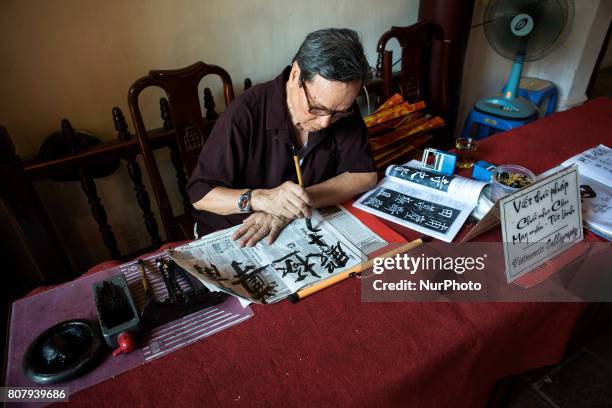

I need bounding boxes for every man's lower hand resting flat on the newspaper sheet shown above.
[232,212,291,247]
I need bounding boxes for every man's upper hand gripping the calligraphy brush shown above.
[251,181,312,219]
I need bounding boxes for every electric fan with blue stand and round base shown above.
[475,0,574,120]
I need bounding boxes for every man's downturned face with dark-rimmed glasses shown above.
[288,63,361,132]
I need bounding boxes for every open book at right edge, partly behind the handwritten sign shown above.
[561,145,612,241]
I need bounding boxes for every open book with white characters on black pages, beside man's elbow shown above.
[354,160,486,242]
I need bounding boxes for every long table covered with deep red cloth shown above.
[9,98,612,407]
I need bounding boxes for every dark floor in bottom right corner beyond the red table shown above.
[507,322,612,408]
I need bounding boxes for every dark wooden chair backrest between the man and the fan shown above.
[376,22,450,119]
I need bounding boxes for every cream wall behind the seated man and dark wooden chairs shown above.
[0,0,418,274]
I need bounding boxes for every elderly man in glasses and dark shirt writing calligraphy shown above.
[187,29,376,246]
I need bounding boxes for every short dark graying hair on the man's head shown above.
[293,28,370,82]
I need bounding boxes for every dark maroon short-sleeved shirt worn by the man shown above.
[187,67,375,235]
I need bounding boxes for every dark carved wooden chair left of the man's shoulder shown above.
[128,61,234,241]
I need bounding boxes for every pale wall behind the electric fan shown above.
[457,0,612,133]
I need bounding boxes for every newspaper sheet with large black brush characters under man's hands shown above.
[168,207,386,303]
